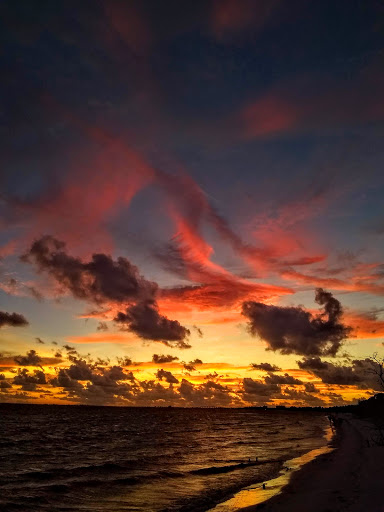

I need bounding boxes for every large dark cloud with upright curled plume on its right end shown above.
[242,288,352,356]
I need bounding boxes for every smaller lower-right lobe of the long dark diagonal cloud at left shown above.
[114,301,191,349]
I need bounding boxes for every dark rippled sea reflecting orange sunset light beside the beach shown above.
[0,404,328,512]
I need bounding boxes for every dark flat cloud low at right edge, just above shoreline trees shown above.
[297,356,382,391]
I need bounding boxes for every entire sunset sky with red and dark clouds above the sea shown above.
[0,0,384,407]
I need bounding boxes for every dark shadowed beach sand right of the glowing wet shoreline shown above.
[237,415,384,512]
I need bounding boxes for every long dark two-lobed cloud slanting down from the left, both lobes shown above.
[22,236,190,348]
